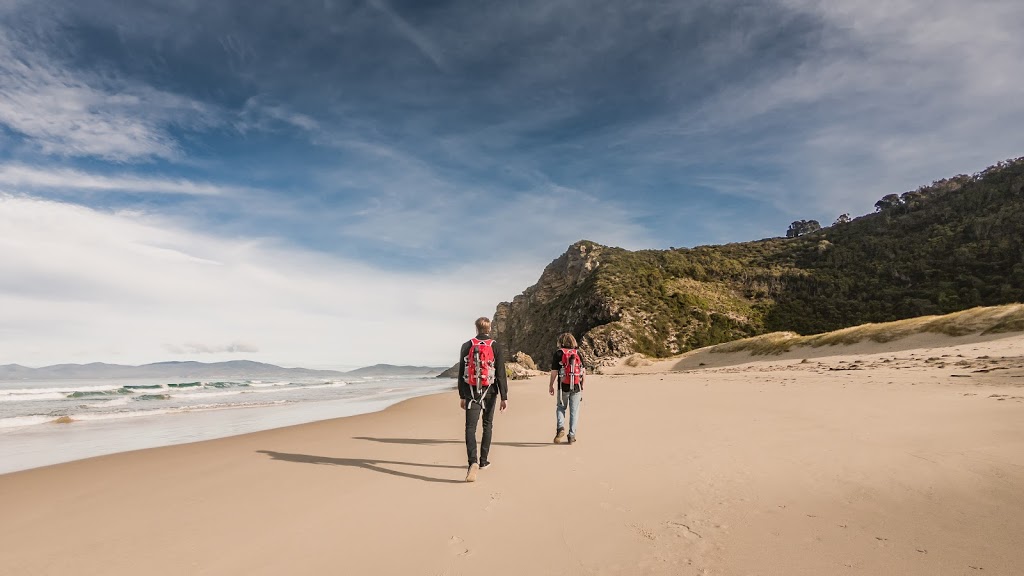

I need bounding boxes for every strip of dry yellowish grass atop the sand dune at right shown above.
[710,304,1024,356]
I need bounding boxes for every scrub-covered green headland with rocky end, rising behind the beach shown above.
[495,159,1024,367]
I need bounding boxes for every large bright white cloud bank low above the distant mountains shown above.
[0,196,538,365]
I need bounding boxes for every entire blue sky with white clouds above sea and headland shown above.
[0,0,1024,366]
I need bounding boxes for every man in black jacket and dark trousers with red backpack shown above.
[459,318,509,482]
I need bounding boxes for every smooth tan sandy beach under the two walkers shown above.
[0,334,1024,576]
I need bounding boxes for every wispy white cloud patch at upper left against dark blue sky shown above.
[0,22,318,163]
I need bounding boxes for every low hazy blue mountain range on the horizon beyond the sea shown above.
[0,360,444,381]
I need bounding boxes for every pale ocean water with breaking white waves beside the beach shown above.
[0,377,455,474]
